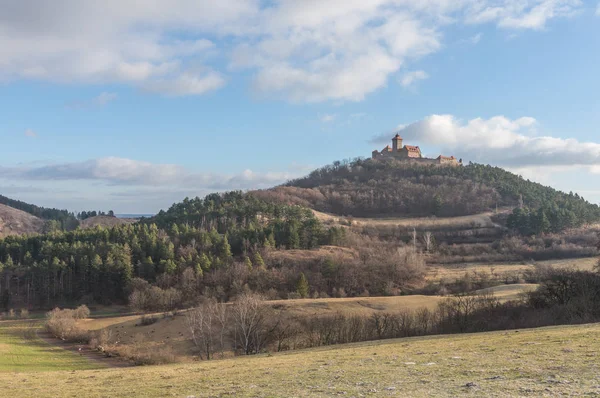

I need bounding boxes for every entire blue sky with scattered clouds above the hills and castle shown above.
[0,0,600,213]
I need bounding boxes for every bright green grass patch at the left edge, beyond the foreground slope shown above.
[0,321,104,374]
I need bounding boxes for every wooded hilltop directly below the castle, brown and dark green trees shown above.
[255,159,600,227]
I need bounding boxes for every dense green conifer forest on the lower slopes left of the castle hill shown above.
[0,193,350,308]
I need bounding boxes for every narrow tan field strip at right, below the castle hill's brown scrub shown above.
[426,258,598,281]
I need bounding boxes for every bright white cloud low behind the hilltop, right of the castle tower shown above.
[372,115,600,171]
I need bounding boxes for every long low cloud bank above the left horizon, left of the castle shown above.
[0,157,297,190]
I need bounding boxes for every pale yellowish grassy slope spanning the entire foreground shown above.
[0,324,600,397]
